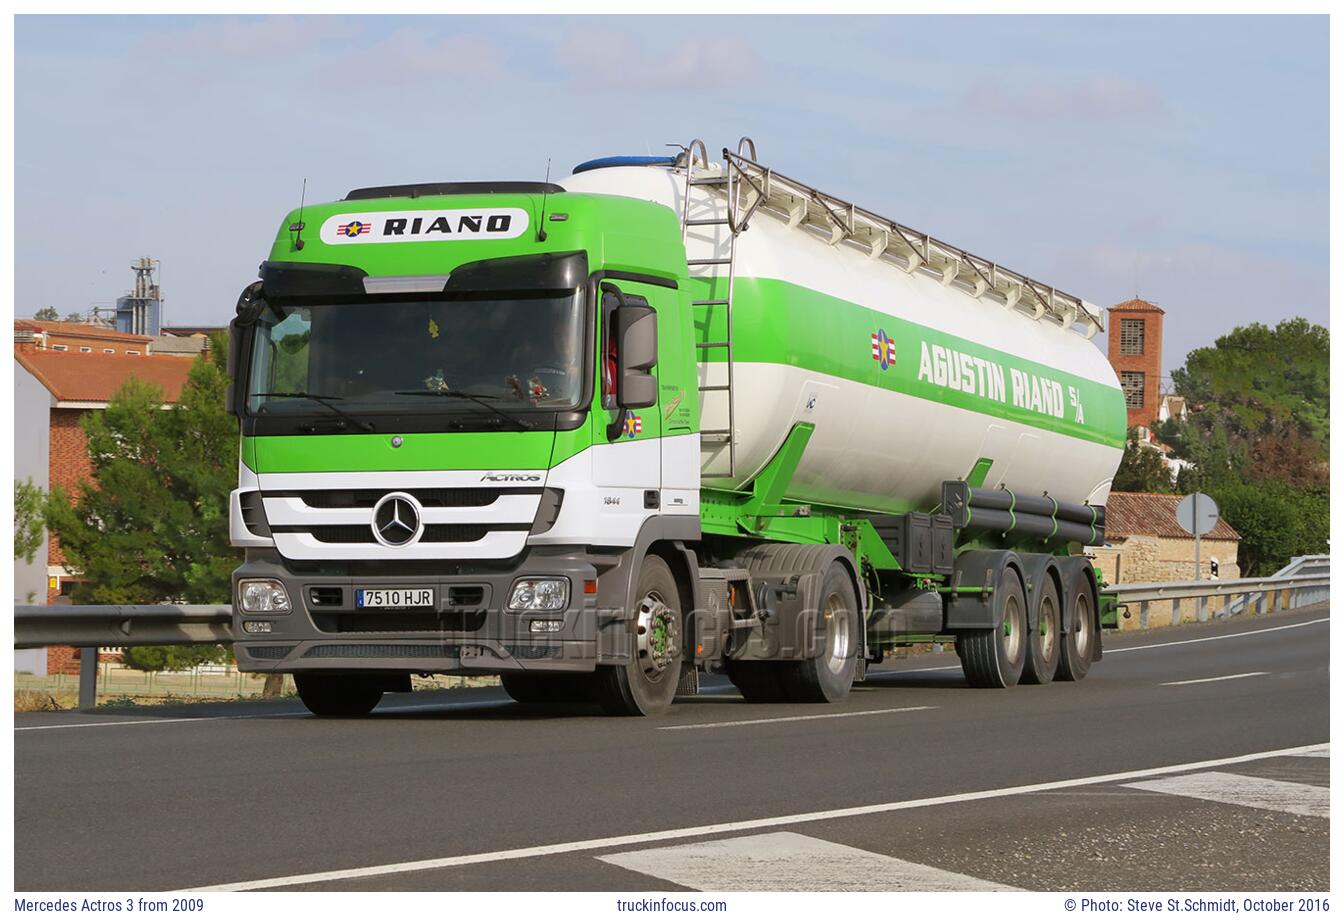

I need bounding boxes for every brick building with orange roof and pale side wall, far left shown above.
[15,333,192,673]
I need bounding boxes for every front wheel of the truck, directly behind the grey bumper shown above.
[593,556,684,716]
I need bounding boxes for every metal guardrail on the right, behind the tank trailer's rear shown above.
[1102,556,1331,629]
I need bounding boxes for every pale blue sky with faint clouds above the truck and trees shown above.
[15,15,1329,371]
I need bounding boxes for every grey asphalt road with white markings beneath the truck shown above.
[15,606,1329,892]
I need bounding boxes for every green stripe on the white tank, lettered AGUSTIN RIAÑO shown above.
[696,278,1125,450]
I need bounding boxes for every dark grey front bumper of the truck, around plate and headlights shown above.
[234,549,599,674]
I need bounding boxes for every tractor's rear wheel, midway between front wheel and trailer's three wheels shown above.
[780,561,862,702]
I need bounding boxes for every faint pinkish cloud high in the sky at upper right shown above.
[961,74,1164,120]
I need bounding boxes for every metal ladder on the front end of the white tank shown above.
[681,137,765,478]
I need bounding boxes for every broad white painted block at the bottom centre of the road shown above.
[597,831,1020,892]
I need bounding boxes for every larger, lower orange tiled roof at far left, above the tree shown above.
[13,352,192,403]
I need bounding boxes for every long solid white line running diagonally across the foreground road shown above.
[186,741,1320,892]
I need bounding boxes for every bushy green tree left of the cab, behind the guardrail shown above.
[47,341,241,666]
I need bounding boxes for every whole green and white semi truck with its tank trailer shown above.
[230,138,1125,716]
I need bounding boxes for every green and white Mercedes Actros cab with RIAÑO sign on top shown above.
[228,183,700,715]
